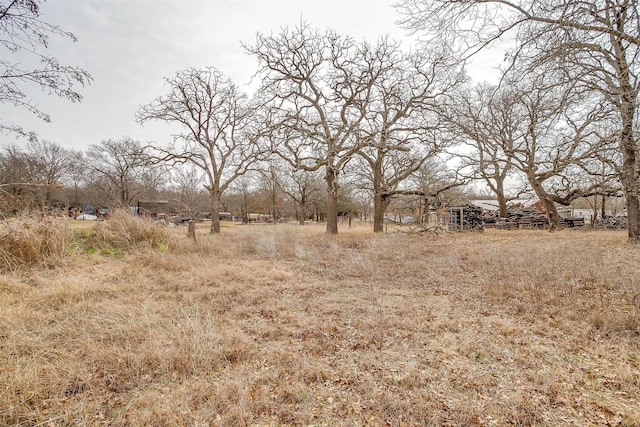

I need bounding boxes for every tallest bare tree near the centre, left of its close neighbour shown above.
[245,24,395,234]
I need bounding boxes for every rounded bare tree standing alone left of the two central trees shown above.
[136,67,261,233]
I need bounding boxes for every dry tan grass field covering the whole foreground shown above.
[0,218,640,427]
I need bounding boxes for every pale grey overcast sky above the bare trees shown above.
[0,0,510,150]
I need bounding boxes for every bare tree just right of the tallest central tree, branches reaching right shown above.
[358,46,464,232]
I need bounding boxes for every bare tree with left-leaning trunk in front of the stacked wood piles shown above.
[492,73,612,230]
